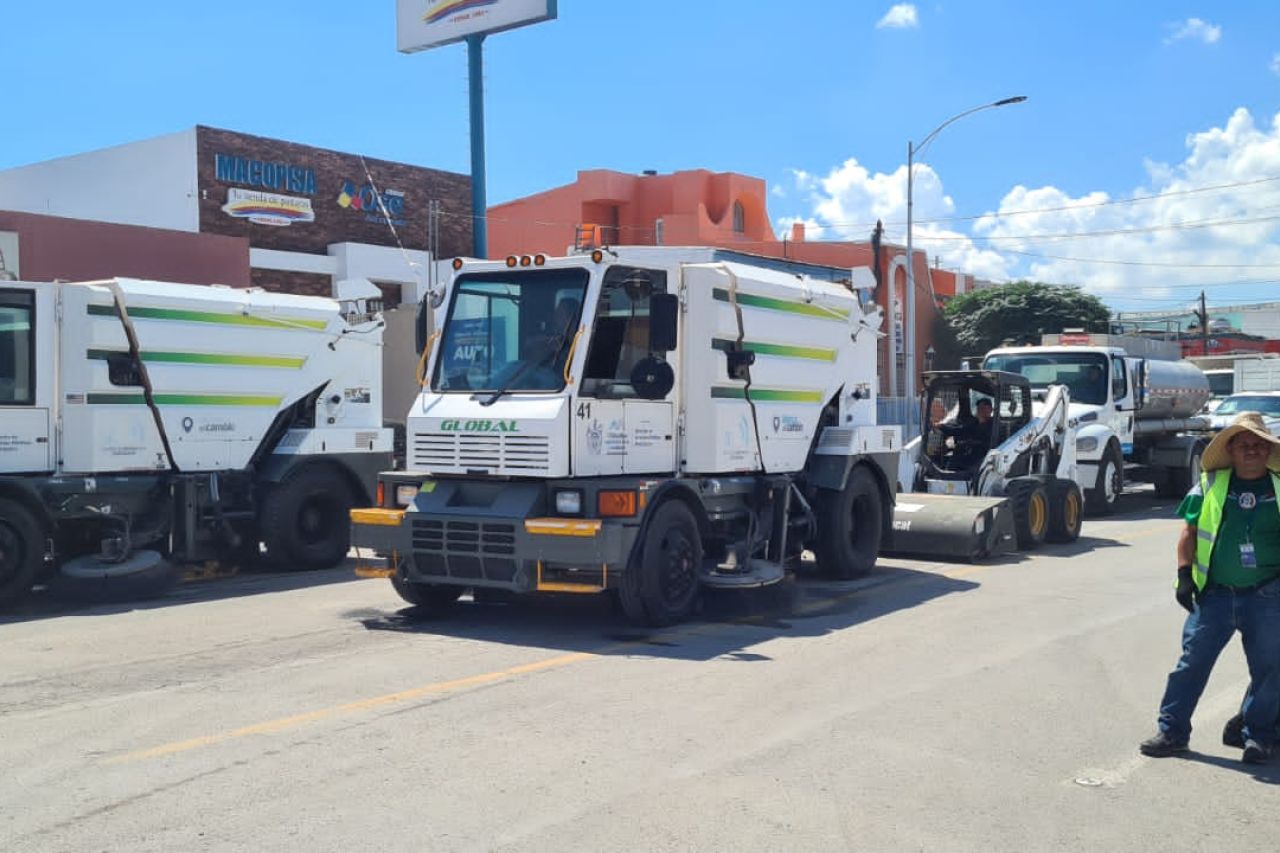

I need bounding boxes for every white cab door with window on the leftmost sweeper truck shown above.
[0,284,54,474]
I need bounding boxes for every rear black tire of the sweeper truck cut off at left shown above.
[259,465,355,569]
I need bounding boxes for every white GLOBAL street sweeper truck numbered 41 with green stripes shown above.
[352,247,899,624]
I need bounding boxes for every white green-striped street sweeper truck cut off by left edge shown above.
[0,279,392,603]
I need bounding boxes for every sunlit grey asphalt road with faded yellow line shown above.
[0,494,1280,852]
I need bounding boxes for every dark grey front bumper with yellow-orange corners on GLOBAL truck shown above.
[351,483,636,593]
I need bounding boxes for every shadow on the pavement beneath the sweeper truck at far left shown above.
[0,560,361,625]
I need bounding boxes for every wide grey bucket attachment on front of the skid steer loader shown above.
[881,494,1016,562]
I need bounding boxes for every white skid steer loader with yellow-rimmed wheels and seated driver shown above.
[892,370,1084,560]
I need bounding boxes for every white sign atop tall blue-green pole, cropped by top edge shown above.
[396,0,557,54]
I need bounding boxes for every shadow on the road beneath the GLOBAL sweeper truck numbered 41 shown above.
[346,565,978,662]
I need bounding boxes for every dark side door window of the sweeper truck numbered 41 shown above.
[582,266,667,400]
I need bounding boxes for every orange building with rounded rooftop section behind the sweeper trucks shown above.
[489,169,968,394]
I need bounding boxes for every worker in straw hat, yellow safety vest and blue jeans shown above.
[1139,412,1280,763]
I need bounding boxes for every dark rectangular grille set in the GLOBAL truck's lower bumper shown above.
[413,519,516,581]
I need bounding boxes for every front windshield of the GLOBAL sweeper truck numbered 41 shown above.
[431,269,588,393]
